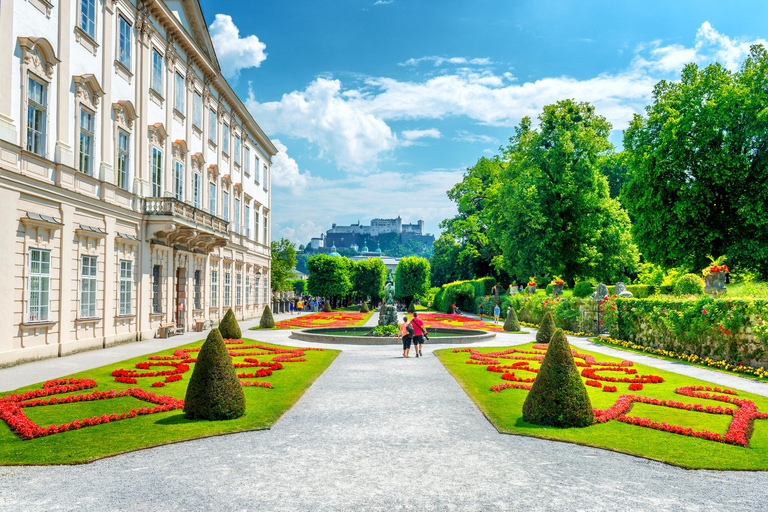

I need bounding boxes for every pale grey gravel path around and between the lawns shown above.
[0,318,768,511]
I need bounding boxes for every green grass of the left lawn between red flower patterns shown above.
[0,340,340,465]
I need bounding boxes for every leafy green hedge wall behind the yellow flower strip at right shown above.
[603,296,768,366]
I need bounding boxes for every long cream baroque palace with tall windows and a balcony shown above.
[0,0,277,366]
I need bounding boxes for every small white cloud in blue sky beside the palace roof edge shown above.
[208,14,267,80]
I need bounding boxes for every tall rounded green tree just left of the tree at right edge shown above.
[494,100,638,286]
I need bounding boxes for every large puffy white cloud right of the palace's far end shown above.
[246,78,397,169]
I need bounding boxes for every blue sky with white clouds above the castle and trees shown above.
[201,0,768,248]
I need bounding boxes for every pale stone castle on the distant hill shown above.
[310,215,435,252]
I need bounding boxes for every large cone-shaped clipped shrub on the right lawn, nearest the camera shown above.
[523,329,595,427]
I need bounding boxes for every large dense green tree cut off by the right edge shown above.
[622,46,768,274]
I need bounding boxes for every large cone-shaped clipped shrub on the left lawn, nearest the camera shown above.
[184,329,245,420]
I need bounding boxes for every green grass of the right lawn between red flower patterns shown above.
[435,344,768,470]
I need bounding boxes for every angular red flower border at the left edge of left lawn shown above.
[0,379,184,439]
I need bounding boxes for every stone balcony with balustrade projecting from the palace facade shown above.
[144,197,229,254]
